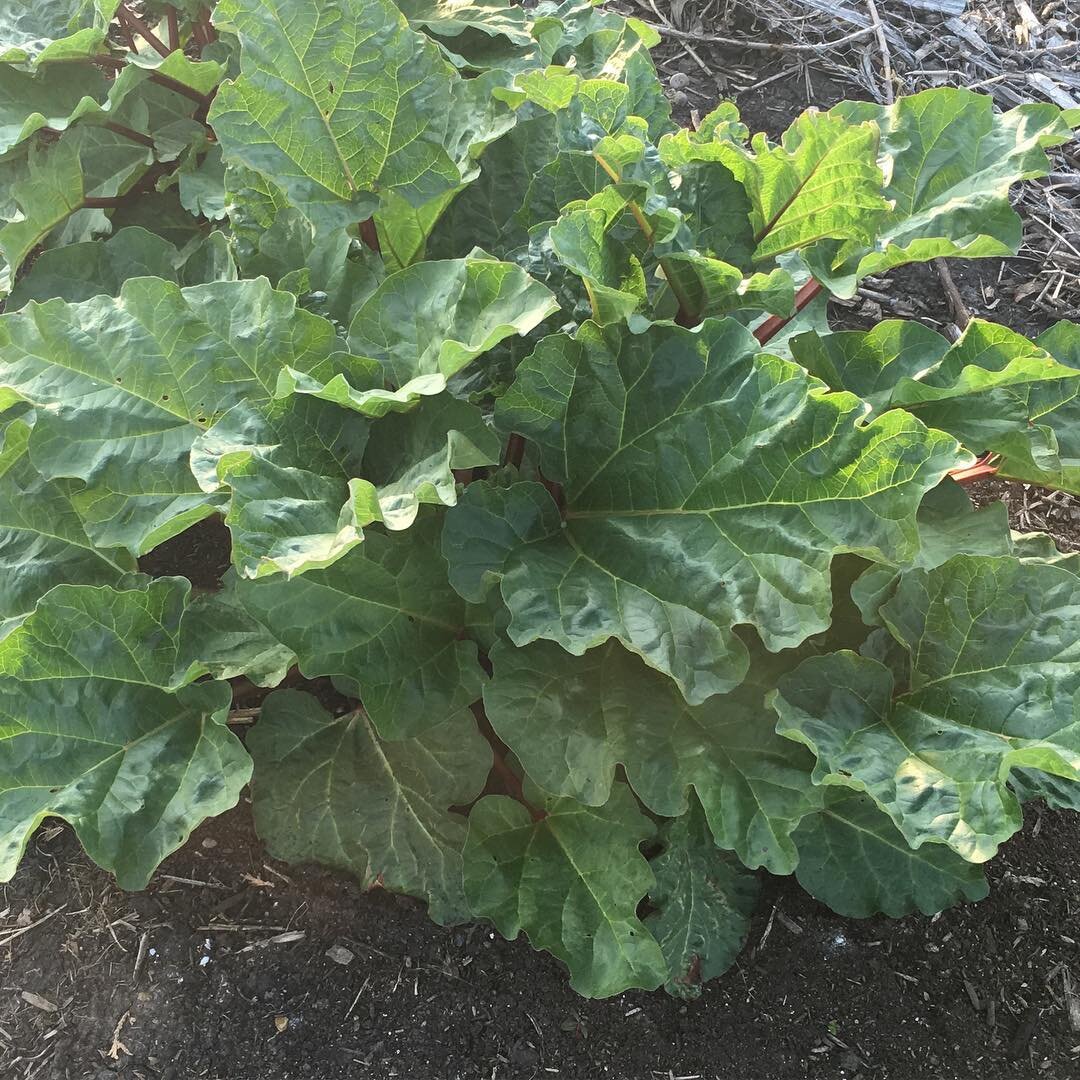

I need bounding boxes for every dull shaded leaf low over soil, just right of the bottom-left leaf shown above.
[248,690,491,924]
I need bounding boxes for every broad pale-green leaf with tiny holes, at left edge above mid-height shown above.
[0,278,338,554]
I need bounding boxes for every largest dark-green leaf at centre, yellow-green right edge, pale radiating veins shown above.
[481,320,964,703]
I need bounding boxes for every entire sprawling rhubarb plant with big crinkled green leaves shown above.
[0,0,1080,996]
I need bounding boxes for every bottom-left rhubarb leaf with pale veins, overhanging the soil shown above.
[0,578,251,889]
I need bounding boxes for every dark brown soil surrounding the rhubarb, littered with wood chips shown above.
[0,0,1080,1080]
